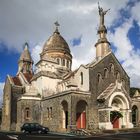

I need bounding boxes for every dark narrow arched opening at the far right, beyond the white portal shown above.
[132,105,138,127]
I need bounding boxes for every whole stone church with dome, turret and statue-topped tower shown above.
[1,7,138,131]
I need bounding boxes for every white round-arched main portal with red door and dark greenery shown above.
[109,92,130,128]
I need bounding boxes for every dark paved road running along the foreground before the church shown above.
[0,133,140,140]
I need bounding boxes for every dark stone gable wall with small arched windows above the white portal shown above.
[89,54,130,100]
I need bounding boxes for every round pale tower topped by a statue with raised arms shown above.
[95,3,111,60]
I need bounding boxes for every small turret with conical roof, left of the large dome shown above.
[17,43,33,74]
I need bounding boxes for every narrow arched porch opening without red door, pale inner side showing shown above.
[61,100,68,129]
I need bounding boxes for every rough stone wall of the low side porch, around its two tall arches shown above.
[42,92,89,131]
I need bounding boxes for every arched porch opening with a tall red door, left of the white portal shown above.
[76,100,87,129]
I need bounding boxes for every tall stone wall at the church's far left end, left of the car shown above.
[1,77,24,131]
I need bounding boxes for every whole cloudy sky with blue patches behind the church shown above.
[0,0,140,105]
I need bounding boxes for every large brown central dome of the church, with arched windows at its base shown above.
[40,22,72,68]
